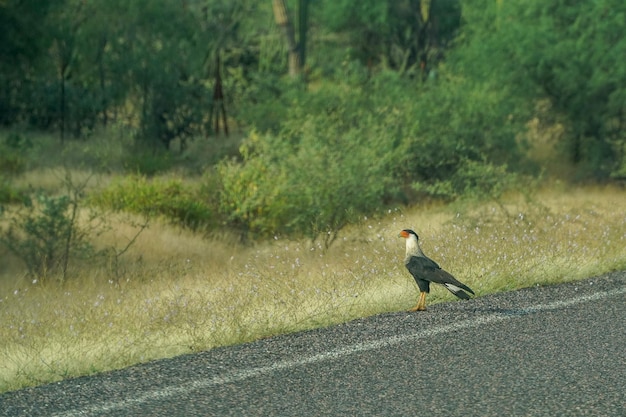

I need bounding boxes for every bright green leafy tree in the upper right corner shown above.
[453,0,626,178]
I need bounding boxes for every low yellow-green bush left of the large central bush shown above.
[90,176,215,228]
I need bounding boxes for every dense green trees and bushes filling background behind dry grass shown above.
[0,0,626,240]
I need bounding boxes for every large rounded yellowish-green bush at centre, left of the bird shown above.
[218,77,399,244]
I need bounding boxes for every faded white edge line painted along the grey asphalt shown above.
[54,288,626,417]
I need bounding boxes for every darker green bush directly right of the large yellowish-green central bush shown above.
[401,74,528,182]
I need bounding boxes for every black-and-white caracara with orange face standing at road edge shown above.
[399,229,474,311]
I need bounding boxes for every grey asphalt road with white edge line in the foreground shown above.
[0,272,626,417]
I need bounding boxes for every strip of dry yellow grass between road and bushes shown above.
[0,187,626,392]
